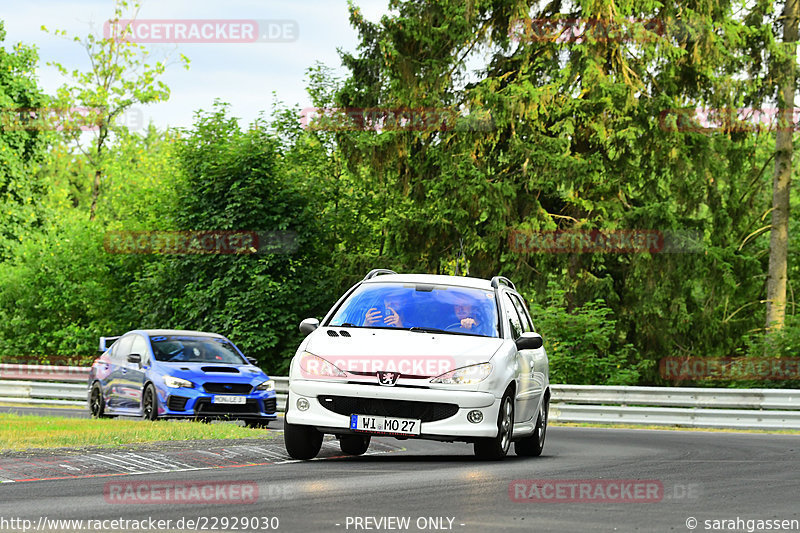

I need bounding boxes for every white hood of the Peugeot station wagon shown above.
[305,328,503,377]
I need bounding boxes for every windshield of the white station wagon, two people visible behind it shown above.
[328,283,500,337]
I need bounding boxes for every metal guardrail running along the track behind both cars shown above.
[0,364,800,429]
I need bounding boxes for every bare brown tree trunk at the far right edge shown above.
[766,0,800,331]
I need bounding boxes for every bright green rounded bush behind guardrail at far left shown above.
[0,219,138,363]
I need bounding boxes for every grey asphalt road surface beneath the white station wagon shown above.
[0,427,800,533]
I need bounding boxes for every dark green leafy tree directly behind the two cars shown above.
[134,104,334,373]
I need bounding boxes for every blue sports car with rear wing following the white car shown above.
[88,330,277,427]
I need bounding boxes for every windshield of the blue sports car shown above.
[150,335,246,365]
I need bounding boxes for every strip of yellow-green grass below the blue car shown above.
[0,413,274,451]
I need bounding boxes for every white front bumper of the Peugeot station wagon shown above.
[286,380,501,441]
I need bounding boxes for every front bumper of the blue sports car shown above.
[158,389,278,420]
